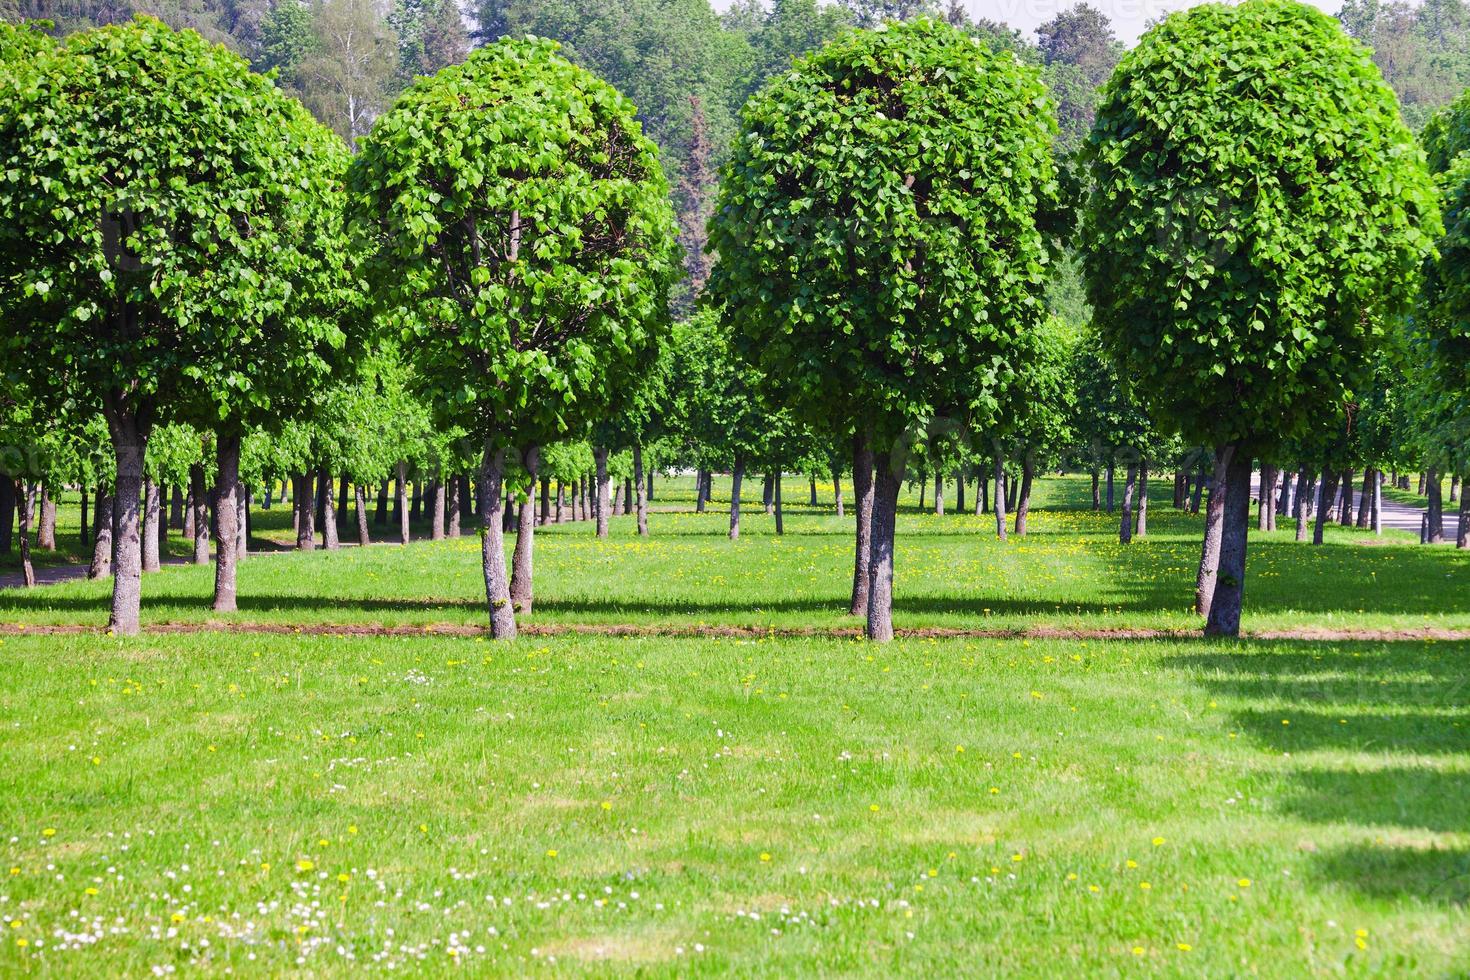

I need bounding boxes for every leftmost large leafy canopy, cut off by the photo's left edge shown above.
[0,16,345,422]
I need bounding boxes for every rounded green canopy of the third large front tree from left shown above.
[710,19,1057,444]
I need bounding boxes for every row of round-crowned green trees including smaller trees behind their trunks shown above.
[0,0,1466,639]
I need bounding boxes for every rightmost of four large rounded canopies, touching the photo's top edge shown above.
[1082,0,1439,448]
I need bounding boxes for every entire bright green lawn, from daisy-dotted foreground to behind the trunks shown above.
[0,480,1470,977]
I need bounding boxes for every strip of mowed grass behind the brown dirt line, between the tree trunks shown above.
[0,478,1470,630]
